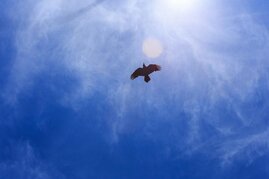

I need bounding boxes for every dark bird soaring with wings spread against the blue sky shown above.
[131,63,161,83]
